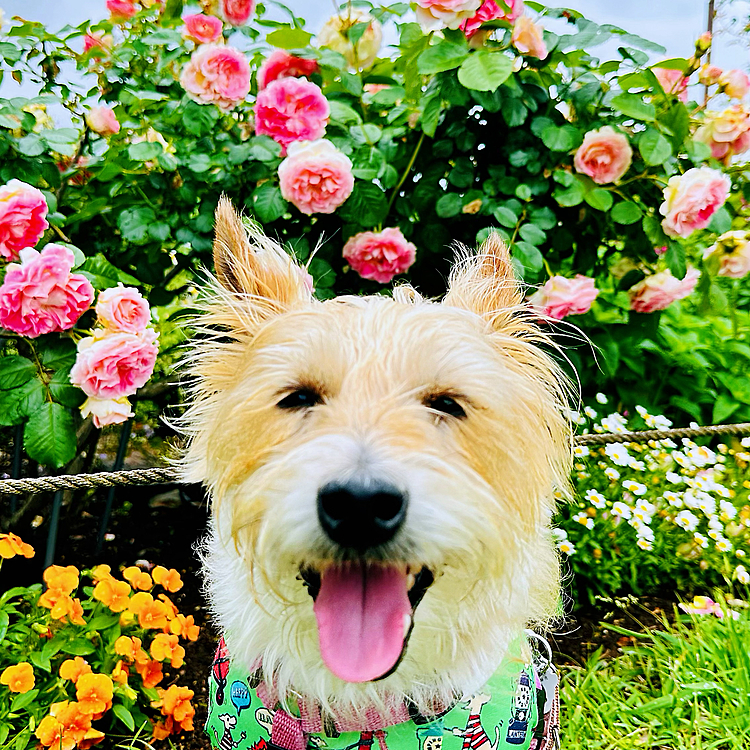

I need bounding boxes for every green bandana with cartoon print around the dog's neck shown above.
[206,643,546,750]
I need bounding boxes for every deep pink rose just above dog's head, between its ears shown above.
[344,227,417,284]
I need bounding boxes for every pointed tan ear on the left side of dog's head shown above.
[214,196,312,312]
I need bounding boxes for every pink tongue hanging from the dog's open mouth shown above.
[313,563,411,682]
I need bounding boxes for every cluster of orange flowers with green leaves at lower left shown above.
[0,534,199,750]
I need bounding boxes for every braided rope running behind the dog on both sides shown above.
[0,422,750,495]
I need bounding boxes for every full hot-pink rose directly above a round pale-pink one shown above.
[255,78,331,156]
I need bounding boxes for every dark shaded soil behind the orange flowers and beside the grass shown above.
[0,430,673,750]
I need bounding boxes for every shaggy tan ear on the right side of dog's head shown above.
[443,233,523,329]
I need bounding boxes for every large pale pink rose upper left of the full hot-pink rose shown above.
[180,44,250,111]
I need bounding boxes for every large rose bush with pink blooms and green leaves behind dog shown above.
[0,0,750,466]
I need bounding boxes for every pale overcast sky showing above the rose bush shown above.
[0,0,750,101]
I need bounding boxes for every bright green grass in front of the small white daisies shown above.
[560,612,750,750]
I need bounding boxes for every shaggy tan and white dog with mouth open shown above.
[179,198,572,748]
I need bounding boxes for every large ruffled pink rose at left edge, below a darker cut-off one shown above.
[0,244,94,338]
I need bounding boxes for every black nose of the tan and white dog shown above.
[318,481,407,552]
